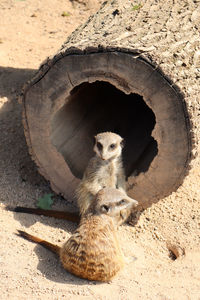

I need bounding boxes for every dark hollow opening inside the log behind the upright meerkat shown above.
[51,81,158,178]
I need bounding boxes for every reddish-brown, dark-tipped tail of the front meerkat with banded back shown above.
[17,230,61,255]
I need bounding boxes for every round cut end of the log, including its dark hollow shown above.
[23,50,191,207]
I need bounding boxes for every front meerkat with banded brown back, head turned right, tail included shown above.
[18,188,137,281]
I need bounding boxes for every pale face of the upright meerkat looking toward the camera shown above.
[94,132,123,160]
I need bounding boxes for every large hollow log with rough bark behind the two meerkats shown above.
[21,0,200,207]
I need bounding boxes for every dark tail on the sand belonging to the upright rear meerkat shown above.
[12,206,80,223]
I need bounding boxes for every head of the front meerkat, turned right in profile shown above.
[91,188,138,225]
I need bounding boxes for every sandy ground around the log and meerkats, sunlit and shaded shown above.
[0,0,200,300]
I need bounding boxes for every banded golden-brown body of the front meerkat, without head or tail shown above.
[60,215,124,281]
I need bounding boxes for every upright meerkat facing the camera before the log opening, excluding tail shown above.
[76,132,126,214]
